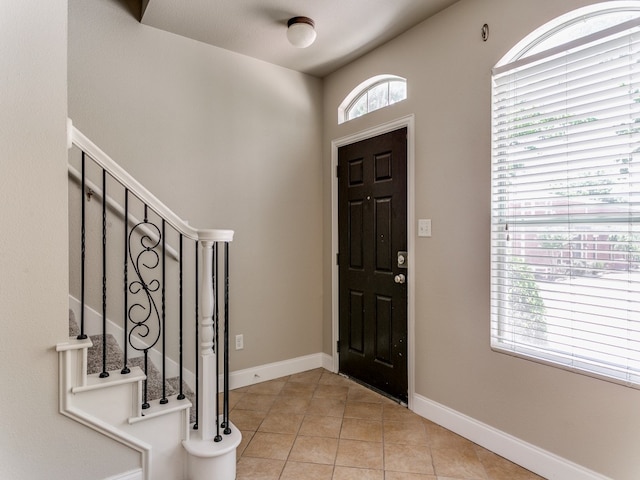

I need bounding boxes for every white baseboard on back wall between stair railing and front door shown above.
[229,353,333,390]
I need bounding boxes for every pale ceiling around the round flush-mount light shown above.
[142,0,457,77]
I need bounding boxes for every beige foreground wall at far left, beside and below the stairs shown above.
[0,0,139,480]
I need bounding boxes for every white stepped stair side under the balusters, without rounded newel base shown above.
[56,338,191,480]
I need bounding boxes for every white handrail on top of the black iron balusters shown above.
[68,120,234,242]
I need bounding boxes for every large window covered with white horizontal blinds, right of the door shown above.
[491,2,640,388]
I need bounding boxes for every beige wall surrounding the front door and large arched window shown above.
[323,0,640,480]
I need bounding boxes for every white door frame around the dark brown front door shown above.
[331,114,416,410]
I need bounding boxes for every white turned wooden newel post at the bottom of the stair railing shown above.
[198,241,218,440]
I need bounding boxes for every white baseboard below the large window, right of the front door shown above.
[413,394,611,480]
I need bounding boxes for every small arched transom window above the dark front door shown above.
[338,75,407,123]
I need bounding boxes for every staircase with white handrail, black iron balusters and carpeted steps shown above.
[56,121,241,480]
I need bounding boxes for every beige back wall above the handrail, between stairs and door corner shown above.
[69,0,322,370]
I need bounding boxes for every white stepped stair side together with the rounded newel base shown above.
[56,337,242,480]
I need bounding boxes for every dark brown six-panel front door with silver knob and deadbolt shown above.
[338,128,408,402]
